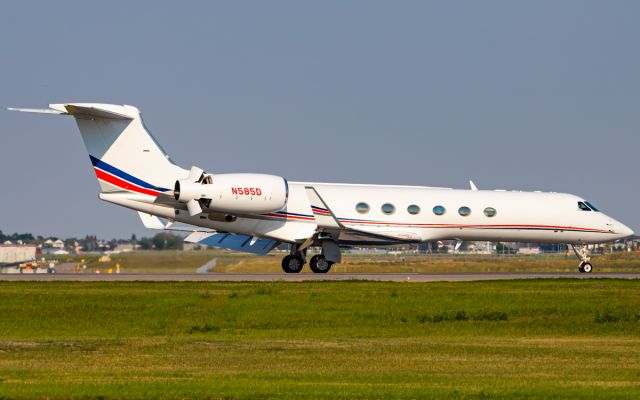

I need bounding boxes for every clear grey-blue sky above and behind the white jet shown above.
[0,1,640,238]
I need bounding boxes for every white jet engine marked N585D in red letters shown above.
[174,174,289,216]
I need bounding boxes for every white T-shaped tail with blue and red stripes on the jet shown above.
[10,103,188,196]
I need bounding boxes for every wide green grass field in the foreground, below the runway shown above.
[0,280,640,399]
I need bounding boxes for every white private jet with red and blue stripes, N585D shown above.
[12,103,633,273]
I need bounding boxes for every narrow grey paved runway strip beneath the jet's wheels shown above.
[0,272,640,282]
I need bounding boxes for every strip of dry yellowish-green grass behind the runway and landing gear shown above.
[60,250,640,273]
